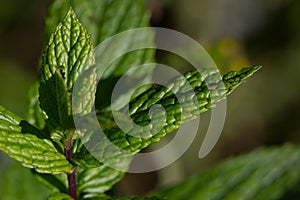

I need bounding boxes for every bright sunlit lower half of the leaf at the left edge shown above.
[0,131,73,174]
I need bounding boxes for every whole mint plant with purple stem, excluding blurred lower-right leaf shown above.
[0,0,278,200]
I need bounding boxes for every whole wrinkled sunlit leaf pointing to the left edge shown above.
[0,106,73,174]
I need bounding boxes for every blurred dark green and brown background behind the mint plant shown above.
[0,0,300,200]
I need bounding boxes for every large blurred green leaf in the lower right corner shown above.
[156,145,300,200]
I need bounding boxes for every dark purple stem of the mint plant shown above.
[65,137,77,200]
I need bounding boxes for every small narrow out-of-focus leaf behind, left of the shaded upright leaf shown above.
[27,81,46,129]
